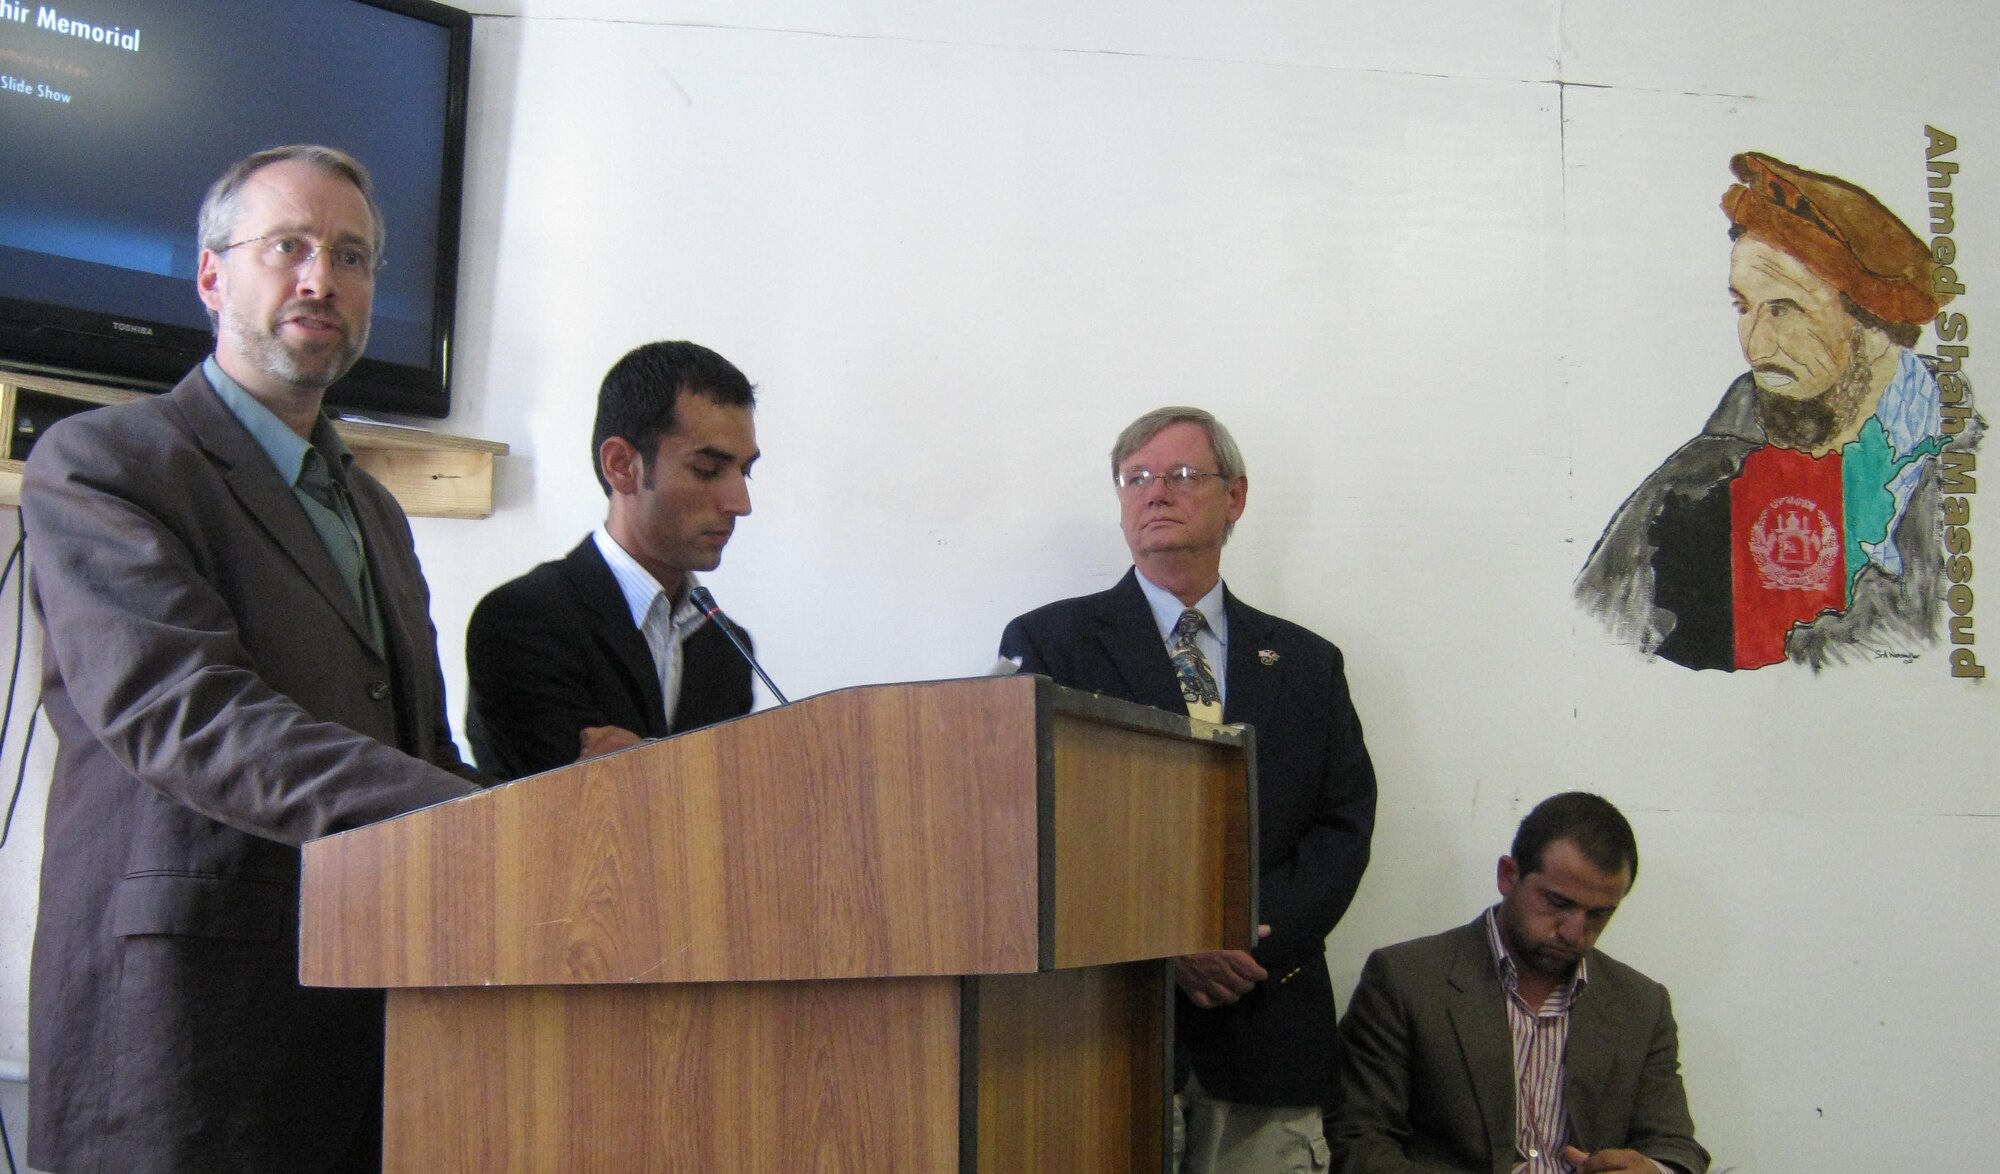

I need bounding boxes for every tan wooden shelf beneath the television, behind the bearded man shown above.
[0,372,508,518]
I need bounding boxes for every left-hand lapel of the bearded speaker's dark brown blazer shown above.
[168,370,374,648]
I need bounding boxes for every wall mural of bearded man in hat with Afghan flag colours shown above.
[1576,154,1980,670]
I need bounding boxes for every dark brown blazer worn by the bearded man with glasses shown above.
[22,370,476,1174]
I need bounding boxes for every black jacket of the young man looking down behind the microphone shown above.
[466,538,750,778]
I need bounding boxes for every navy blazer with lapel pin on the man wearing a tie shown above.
[1000,570,1376,1106]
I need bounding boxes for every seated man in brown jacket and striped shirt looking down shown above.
[1328,792,1708,1174]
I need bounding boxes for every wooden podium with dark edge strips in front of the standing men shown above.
[300,676,1256,1174]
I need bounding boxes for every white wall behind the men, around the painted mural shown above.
[0,0,2000,1170]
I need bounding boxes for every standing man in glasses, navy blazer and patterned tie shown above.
[1000,408,1376,1174]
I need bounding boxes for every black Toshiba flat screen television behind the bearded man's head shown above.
[0,0,472,416]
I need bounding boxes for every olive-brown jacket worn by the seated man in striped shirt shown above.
[1328,918,1708,1174]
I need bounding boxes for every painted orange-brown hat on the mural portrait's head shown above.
[1722,152,1952,324]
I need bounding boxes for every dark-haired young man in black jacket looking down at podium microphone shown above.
[466,342,758,778]
